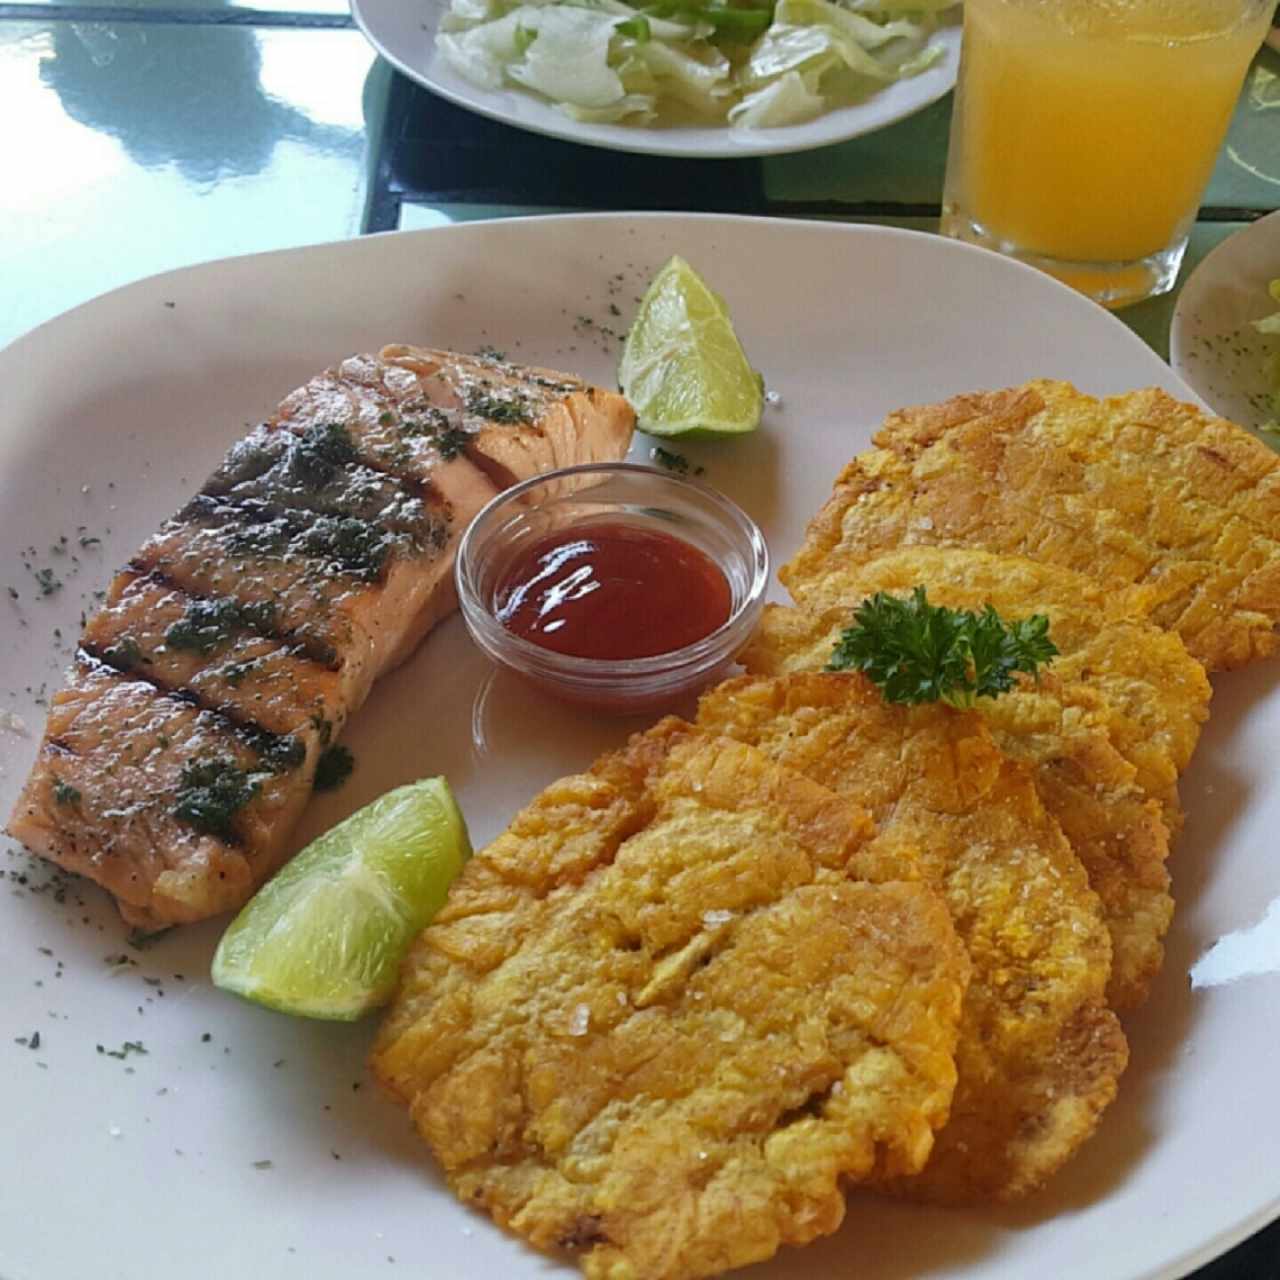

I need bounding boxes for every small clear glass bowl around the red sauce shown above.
[454,462,769,716]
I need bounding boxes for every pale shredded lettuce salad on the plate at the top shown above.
[436,0,956,129]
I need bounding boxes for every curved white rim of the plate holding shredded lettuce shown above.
[351,0,960,160]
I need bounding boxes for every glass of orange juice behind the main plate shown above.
[942,0,1275,307]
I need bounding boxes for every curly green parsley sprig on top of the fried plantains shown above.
[827,586,1057,707]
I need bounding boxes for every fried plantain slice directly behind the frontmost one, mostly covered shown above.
[698,675,1128,1203]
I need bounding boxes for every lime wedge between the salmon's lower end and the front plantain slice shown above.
[212,778,471,1021]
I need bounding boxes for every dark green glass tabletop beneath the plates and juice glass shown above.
[0,0,1280,1280]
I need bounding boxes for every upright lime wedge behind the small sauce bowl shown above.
[618,257,764,436]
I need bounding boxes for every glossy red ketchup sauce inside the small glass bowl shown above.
[495,521,733,660]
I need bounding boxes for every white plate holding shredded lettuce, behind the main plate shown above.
[351,0,960,159]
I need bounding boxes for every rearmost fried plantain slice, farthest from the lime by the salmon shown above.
[778,380,1280,671]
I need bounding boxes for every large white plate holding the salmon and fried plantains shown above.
[0,216,1280,1280]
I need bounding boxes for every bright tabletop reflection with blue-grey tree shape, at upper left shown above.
[0,19,380,343]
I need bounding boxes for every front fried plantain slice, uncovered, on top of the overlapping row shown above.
[372,719,969,1280]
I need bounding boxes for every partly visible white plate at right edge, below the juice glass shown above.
[1169,212,1280,442]
